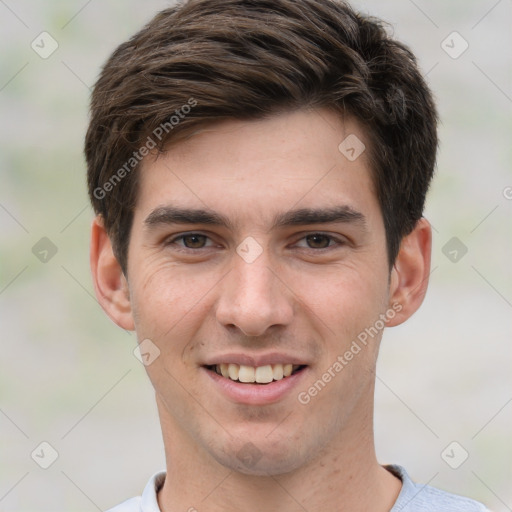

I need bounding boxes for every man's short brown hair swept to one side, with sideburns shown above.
[85,0,437,273]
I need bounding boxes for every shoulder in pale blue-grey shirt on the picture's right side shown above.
[386,465,488,512]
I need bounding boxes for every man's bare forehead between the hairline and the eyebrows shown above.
[136,110,379,226]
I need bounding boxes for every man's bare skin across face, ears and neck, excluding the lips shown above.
[91,106,431,512]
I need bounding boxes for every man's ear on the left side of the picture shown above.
[90,215,135,331]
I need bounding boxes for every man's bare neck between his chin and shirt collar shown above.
[158,396,401,512]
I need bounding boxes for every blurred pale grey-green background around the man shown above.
[0,0,512,512]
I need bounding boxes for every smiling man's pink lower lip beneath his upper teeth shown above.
[201,367,308,405]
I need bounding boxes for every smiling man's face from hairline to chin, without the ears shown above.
[128,110,391,474]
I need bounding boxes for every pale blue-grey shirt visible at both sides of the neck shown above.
[107,465,489,512]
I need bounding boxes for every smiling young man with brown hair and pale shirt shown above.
[85,0,485,512]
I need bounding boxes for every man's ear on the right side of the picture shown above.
[387,218,432,327]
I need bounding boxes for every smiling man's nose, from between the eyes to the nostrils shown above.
[216,253,293,336]
